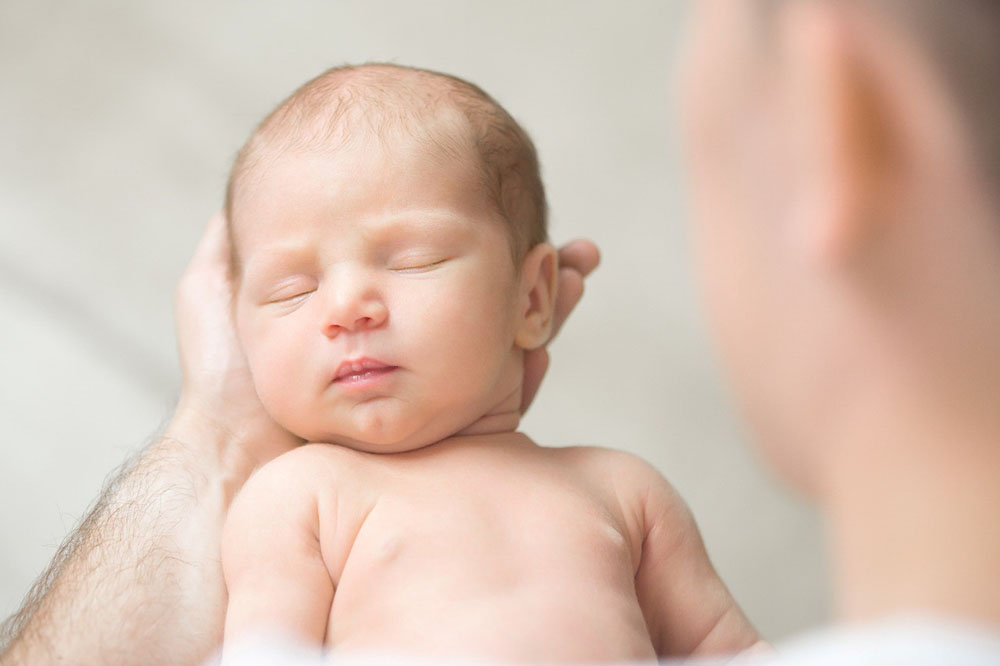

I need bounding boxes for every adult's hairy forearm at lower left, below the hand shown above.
[2,422,252,664]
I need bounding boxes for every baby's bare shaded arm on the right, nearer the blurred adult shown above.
[635,466,764,657]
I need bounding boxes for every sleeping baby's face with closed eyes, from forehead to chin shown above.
[233,141,521,452]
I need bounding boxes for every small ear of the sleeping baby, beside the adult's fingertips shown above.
[514,243,559,349]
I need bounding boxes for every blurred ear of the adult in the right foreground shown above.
[779,2,892,262]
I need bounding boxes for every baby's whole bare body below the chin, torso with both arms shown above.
[223,432,758,662]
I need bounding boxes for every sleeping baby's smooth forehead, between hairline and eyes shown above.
[230,138,507,259]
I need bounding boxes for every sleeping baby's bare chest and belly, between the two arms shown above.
[306,440,652,658]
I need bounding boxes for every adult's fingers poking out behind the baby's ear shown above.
[521,240,601,414]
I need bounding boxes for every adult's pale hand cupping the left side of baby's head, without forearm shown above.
[167,213,302,466]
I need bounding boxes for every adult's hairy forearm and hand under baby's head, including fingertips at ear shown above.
[0,215,599,665]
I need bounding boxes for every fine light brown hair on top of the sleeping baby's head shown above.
[225,63,548,274]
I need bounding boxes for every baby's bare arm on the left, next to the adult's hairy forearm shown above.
[222,451,334,646]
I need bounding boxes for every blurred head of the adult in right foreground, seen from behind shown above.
[682,0,1000,491]
